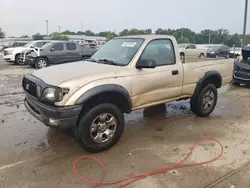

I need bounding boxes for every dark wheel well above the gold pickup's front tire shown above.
[78,91,131,119]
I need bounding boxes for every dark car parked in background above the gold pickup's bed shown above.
[207,45,230,58]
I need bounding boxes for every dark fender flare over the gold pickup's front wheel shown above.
[75,84,132,110]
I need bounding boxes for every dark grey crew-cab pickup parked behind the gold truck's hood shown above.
[21,41,97,69]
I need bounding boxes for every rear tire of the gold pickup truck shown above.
[190,84,218,117]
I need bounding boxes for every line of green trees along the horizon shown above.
[0,28,250,46]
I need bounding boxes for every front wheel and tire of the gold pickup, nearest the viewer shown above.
[77,103,124,153]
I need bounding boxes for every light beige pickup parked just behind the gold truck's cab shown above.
[178,43,206,60]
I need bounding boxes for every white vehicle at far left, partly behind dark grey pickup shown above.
[3,40,49,65]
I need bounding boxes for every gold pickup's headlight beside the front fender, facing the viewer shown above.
[42,87,69,102]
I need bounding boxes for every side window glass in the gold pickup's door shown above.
[140,39,175,66]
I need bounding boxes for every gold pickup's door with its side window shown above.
[132,39,183,109]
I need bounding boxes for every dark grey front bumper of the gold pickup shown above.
[24,93,81,129]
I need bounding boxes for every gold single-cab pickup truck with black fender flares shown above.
[22,35,233,152]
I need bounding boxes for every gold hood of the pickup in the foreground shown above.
[32,61,124,86]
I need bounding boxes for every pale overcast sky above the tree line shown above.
[0,0,250,36]
